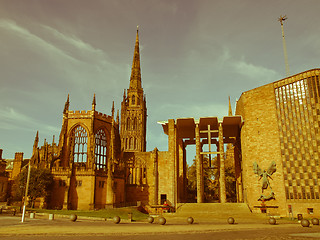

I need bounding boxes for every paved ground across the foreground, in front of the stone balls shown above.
[0,214,320,239]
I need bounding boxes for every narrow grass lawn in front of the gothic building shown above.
[31,207,148,221]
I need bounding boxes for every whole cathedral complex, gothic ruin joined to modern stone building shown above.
[0,28,320,216]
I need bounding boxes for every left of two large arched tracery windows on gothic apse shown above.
[72,126,88,163]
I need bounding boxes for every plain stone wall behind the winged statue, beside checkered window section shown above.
[236,84,287,215]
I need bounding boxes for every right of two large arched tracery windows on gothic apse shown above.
[95,129,107,169]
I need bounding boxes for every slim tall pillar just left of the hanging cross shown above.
[195,124,204,203]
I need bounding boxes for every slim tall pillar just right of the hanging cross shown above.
[219,122,226,203]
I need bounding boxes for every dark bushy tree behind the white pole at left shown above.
[16,168,54,207]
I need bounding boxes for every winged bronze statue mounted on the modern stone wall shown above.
[253,161,276,201]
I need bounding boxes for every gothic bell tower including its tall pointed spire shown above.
[120,29,147,152]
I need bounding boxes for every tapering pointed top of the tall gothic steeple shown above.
[130,26,141,89]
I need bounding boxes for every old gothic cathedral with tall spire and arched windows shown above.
[11,30,186,209]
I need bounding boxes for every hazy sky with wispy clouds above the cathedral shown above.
[0,0,320,163]
